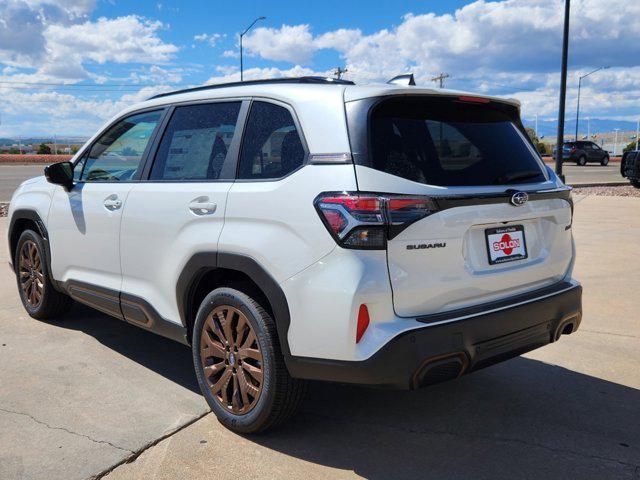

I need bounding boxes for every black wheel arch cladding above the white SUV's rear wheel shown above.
[176,252,291,363]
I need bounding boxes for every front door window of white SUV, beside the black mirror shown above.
[81,111,162,182]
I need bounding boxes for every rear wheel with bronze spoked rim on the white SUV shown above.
[192,288,306,433]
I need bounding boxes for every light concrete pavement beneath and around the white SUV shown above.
[0,196,640,480]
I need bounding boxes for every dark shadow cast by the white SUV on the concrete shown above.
[46,305,640,480]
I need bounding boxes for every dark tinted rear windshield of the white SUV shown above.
[370,97,546,186]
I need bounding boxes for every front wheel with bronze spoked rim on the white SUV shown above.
[13,230,73,320]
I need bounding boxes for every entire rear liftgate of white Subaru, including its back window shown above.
[347,96,573,317]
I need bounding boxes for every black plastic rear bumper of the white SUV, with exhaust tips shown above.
[287,284,582,389]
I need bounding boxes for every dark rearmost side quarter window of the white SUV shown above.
[238,102,305,179]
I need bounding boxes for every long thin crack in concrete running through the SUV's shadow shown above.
[302,412,640,470]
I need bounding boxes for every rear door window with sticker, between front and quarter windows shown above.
[150,102,240,181]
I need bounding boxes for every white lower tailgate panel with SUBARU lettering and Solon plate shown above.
[387,189,572,316]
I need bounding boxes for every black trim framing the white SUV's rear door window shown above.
[139,97,250,184]
